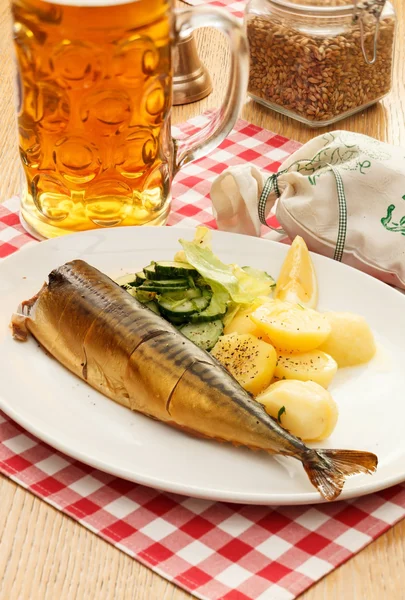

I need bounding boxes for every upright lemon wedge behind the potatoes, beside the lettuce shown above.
[275,235,318,308]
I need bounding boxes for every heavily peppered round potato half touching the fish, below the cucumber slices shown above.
[211,333,277,395]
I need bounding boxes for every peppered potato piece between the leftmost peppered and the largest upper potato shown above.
[274,349,338,388]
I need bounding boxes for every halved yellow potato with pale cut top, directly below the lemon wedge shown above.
[251,300,331,353]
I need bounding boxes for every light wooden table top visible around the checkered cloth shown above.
[0,0,405,600]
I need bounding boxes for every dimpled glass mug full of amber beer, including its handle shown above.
[12,0,248,238]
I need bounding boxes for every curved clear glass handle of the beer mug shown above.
[173,8,249,174]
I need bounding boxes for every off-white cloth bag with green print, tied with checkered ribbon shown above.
[211,131,405,289]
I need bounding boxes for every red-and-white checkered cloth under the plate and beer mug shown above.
[0,115,405,600]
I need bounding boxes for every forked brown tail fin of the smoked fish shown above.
[303,450,378,501]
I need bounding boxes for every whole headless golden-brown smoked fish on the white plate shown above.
[10,260,377,500]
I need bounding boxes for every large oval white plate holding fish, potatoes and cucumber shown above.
[0,227,405,505]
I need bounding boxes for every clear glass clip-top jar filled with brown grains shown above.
[245,0,396,127]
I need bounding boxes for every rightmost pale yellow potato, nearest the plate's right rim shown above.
[319,312,376,367]
